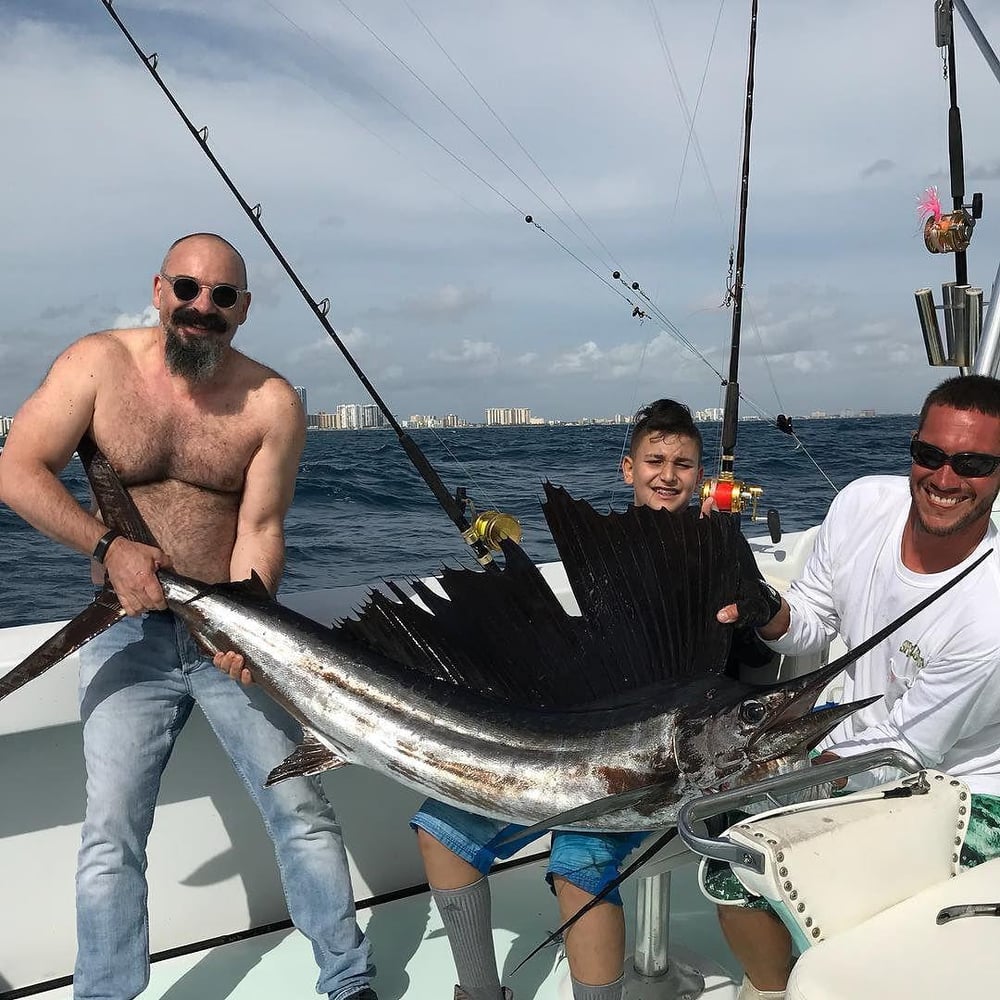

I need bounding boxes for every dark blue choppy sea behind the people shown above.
[0,416,916,627]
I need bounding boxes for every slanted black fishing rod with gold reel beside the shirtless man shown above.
[101,0,521,572]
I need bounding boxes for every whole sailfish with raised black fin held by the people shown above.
[4,439,978,838]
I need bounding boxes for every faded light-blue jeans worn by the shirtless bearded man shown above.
[73,612,373,1000]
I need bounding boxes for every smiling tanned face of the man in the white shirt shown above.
[910,405,1000,549]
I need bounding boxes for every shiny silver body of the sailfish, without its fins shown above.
[160,572,853,830]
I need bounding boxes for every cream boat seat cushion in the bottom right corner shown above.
[786,859,1000,1000]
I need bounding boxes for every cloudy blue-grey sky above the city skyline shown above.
[0,0,1000,421]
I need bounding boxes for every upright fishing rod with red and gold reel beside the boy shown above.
[701,0,791,542]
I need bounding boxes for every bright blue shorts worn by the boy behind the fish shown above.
[410,799,646,906]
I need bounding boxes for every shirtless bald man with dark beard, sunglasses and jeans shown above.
[0,233,375,1000]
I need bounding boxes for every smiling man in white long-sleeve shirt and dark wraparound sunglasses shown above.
[719,375,1000,1000]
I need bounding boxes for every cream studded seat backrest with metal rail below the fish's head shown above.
[727,771,971,950]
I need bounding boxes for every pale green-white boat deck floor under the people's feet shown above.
[11,860,737,1000]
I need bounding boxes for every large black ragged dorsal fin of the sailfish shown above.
[340,483,752,708]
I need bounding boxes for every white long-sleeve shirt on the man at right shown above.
[768,476,1000,795]
